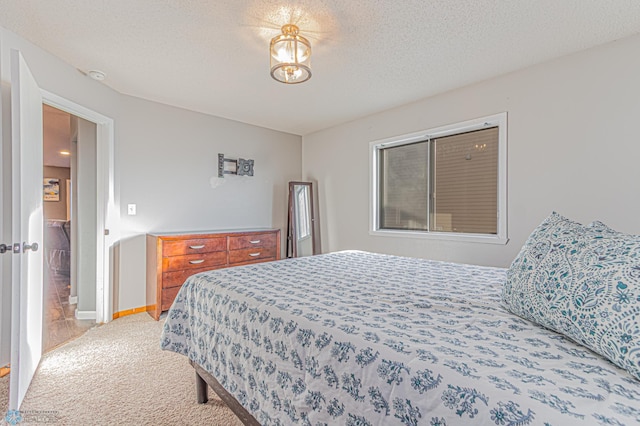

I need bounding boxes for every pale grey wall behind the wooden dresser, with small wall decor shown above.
[115,96,302,311]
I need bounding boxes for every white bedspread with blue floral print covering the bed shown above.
[161,251,640,426]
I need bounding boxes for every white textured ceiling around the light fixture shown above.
[0,0,640,135]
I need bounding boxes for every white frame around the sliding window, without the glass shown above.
[369,112,509,244]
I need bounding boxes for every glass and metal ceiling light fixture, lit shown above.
[269,24,311,84]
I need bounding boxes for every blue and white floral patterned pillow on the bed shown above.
[502,212,640,380]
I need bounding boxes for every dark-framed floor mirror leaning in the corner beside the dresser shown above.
[287,182,316,257]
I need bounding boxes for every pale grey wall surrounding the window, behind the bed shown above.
[303,36,640,266]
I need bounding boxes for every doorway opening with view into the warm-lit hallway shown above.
[42,104,96,352]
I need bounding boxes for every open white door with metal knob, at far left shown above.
[9,50,43,410]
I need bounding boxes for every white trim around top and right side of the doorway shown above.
[42,90,120,324]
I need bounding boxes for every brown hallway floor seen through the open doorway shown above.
[42,270,96,352]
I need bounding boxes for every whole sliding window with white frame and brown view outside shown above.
[371,113,507,244]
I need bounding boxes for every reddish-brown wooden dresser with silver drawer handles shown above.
[147,229,280,321]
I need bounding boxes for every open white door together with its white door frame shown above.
[0,49,119,409]
